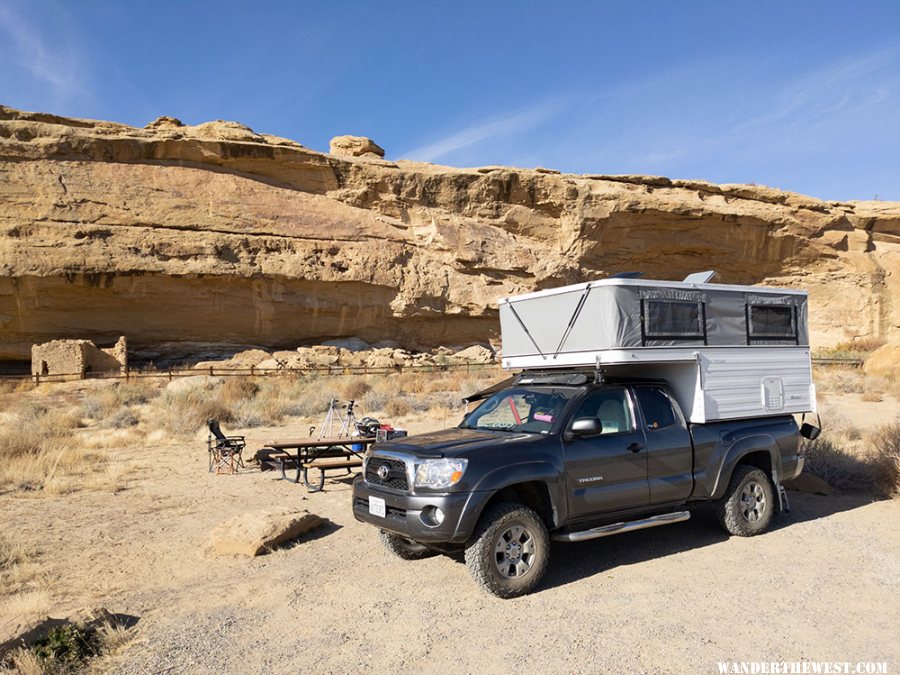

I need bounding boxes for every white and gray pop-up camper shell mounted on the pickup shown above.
[500,277,816,423]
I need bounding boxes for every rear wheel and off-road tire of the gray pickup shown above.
[716,464,776,537]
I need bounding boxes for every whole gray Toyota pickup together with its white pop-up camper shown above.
[353,273,819,598]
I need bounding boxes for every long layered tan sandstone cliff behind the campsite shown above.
[0,107,900,359]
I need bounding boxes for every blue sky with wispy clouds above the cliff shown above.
[0,0,900,200]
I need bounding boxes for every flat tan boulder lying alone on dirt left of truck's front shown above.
[210,508,322,556]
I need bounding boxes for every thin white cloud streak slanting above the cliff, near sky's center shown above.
[403,99,567,162]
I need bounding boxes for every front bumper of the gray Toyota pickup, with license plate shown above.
[353,476,487,544]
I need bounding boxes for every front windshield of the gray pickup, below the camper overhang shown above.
[459,387,576,434]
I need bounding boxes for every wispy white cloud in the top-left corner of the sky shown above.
[0,5,86,100]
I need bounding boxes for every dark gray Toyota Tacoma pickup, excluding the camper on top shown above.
[353,372,803,598]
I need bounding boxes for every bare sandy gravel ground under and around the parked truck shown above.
[0,412,900,673]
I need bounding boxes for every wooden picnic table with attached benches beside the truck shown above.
[262,436,375,492]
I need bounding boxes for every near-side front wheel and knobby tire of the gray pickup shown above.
[465,503,550,598]
